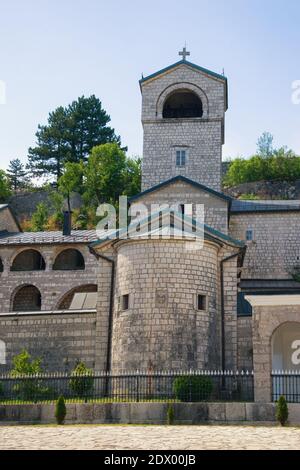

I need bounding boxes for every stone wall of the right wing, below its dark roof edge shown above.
[229,212,300,279]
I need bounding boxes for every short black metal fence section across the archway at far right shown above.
[272,371,300,403]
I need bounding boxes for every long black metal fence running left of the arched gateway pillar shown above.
[0,371,254,404]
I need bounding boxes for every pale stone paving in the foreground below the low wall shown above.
[0,425,300,450]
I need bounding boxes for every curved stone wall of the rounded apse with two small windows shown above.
[112,240,220,370]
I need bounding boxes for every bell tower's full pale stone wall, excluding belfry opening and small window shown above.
[142,64,225,190]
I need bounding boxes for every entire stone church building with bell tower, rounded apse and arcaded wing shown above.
[0,50,300,401]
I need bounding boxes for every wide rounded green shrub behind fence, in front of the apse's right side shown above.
[173,375,213,402]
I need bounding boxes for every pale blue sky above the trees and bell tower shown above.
[0,0,300,169]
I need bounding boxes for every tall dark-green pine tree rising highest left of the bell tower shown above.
[28,95,120,180]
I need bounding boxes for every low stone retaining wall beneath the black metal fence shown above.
[0,403,300,425]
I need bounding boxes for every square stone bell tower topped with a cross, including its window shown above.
[140,48,227,191]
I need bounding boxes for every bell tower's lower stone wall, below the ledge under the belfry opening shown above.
[142,118,222,191]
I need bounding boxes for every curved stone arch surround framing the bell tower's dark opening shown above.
[156,82,209,119]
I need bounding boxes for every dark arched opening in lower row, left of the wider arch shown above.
[11,284,42,312]
